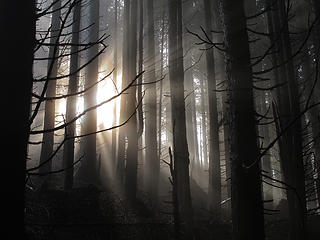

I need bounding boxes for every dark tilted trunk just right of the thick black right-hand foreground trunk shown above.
[266,0,306,240]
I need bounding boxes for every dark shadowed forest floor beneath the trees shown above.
[25,183,320,240]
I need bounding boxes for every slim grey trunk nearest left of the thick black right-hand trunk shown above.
[204,0,221,221]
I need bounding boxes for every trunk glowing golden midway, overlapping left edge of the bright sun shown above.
[79,0,100,184]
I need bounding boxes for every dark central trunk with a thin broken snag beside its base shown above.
[168,0,193,239]
